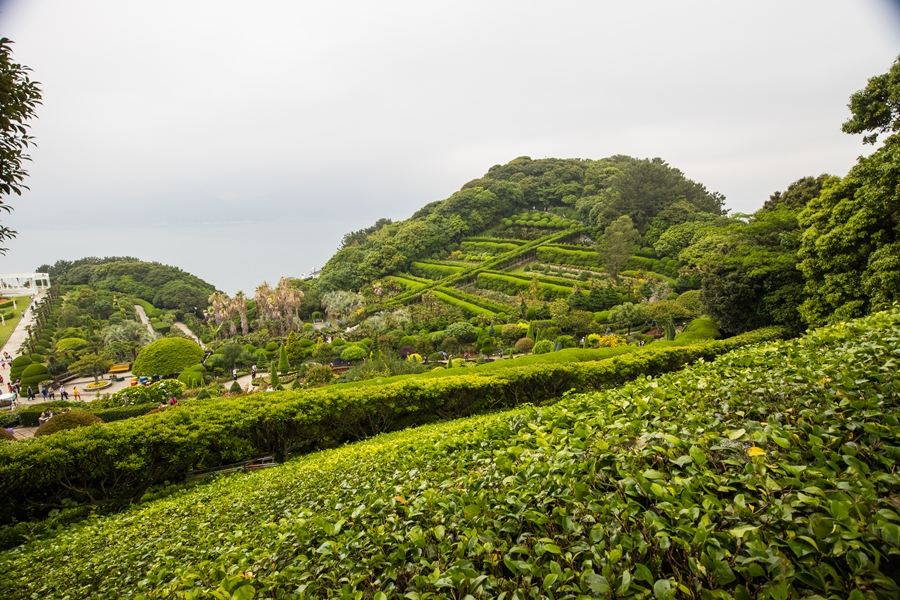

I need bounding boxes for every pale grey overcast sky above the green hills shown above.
[0,0,900,293]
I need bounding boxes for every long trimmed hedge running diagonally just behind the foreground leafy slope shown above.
[0,328,781,522]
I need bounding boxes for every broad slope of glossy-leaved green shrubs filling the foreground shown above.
[0,311,900,600]
